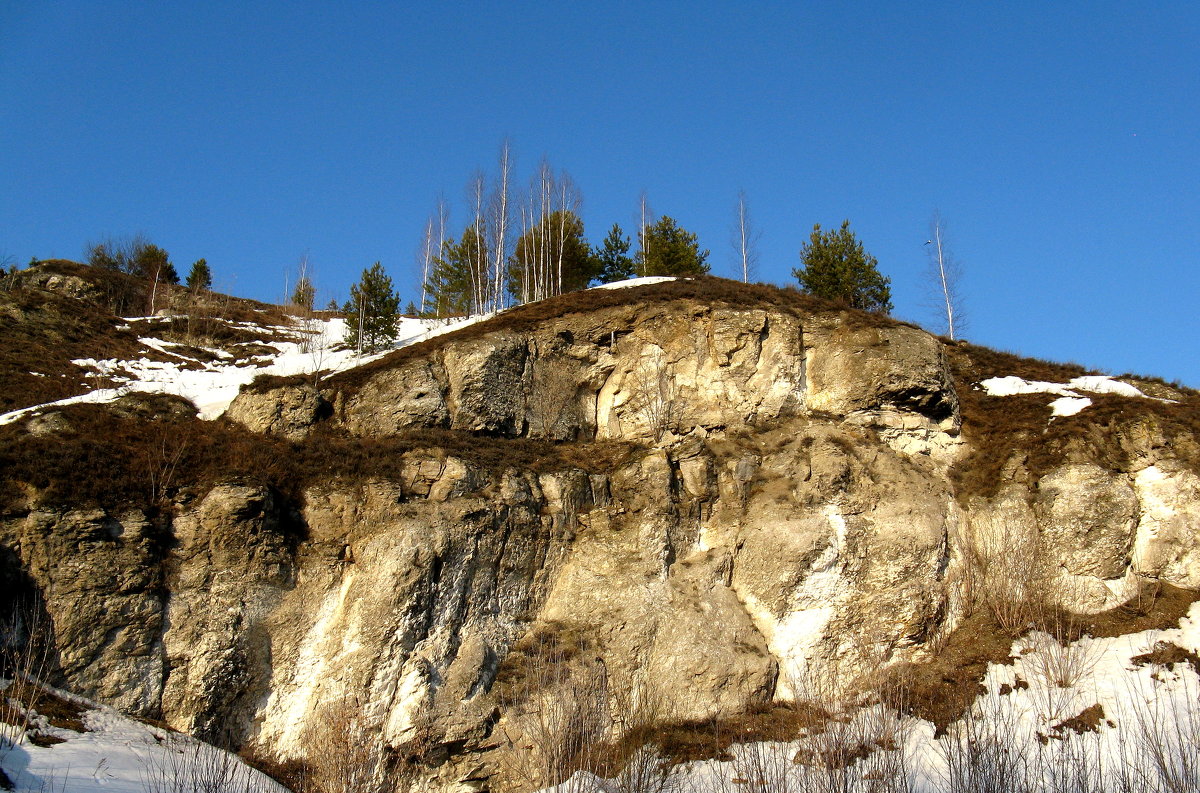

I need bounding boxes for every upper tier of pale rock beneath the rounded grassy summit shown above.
[228,304,958,448]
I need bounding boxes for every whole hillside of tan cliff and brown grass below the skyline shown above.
[0,268,1200,789]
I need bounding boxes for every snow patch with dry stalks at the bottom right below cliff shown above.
[556,603,1200,793]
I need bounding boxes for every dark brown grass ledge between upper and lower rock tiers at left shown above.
[0,396,638,510]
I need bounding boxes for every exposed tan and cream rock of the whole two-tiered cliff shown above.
[0,281,1200,789]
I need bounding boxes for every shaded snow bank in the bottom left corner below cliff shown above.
[0,680,287,793]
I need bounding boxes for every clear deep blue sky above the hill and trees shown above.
[0,0,1200,386]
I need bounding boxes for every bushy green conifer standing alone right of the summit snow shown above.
[792,221,892,313]
